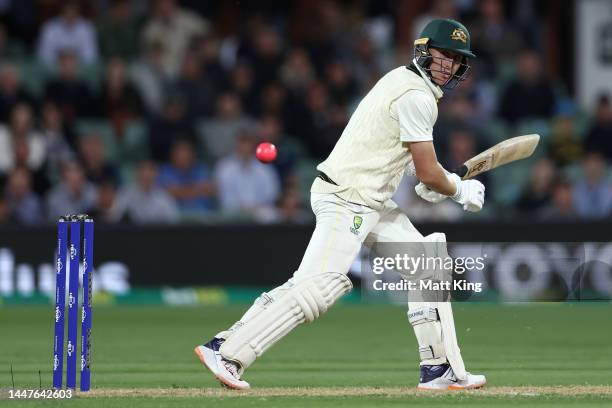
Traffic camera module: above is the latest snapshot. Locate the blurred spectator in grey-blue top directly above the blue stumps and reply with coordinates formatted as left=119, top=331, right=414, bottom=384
left=47, top=162, right=98, bottom=220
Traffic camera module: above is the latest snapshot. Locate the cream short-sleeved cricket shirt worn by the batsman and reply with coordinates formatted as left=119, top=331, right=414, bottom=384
left=310, top=66, right=442, bottom=209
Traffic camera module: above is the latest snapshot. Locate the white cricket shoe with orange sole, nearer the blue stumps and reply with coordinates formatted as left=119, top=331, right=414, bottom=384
left=195, top=337, right=251, bottom=390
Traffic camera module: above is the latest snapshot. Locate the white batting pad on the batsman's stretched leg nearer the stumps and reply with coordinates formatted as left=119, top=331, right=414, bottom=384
left=219, top=272, right=353, bottom=369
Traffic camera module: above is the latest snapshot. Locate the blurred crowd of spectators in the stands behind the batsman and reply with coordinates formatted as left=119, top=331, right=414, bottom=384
left=0, top=0, right=612, bottom=224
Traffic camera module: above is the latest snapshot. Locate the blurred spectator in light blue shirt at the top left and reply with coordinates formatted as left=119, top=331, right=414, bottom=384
left=38, top=0, right=98, bottom=67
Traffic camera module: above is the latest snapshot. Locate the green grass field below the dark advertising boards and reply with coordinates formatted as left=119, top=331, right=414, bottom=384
left=0, top=303, right=612, bottom=407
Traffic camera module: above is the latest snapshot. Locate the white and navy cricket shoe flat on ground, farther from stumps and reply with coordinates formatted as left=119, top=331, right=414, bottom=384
left=417, top=364, right=487, bottom=390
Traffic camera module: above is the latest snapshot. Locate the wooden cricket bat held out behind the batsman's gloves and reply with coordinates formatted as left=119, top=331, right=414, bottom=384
left=453, top=134, right=540, bottom=180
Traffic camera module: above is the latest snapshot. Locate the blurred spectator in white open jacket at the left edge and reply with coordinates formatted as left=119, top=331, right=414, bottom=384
left=0, top=103, right=46, bottom=174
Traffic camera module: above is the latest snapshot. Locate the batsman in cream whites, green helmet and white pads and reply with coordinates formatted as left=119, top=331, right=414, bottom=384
left=195, top=19, right=486, bottom=390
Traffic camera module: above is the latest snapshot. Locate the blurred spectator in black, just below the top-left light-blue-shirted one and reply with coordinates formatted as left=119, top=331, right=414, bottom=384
left=45, top=51, right=96, bottom=124
